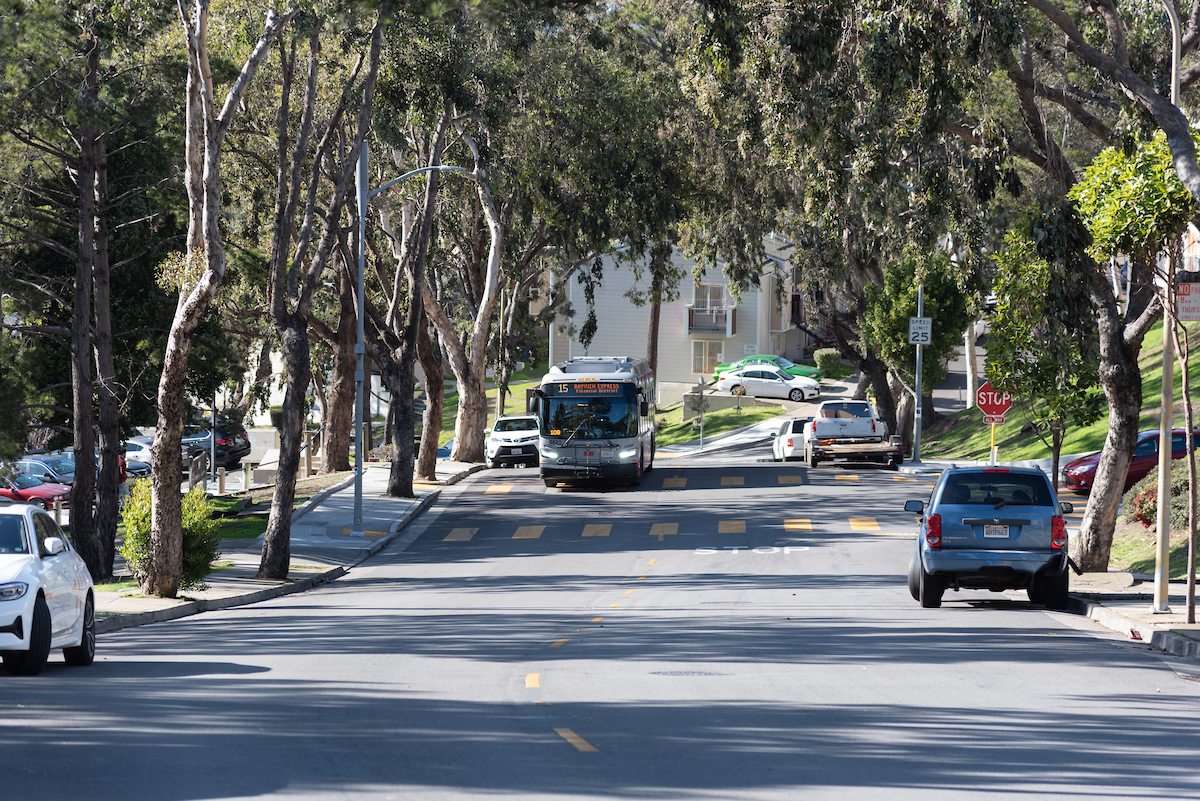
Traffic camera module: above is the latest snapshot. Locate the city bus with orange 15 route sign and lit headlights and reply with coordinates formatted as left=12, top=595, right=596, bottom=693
left=530, top=356, right=654, bottom=487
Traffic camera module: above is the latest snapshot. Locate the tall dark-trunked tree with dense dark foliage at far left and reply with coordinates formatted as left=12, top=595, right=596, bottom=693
left=0, top=2, right=182, bottom=579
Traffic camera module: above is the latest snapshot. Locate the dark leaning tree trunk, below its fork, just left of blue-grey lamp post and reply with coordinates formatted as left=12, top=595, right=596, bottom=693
left=254, top=314, right=312, bottom=579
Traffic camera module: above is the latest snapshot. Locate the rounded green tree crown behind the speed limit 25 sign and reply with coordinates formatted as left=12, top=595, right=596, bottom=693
left=863, top=252, right=971, bottom=387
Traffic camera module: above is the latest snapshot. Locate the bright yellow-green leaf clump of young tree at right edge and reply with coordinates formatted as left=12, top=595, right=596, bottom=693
left=1069, top=131, right=1198, bottom=261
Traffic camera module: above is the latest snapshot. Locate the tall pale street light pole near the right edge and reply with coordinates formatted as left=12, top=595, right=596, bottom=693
left=1150, top=0, right=1190, bottom=614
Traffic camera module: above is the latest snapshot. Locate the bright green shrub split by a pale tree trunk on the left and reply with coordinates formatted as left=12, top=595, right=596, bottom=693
left=121, top=480, right=221, bottom=590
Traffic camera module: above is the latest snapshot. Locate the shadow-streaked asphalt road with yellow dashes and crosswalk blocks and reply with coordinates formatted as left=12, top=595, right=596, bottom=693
left=7, top=446, right=1200, bottom=801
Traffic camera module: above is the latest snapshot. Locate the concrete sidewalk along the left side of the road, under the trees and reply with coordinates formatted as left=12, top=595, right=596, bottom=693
left=96, top=462, right=484, bottom=632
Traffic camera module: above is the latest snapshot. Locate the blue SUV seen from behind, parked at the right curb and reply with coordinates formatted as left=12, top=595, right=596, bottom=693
left=904, top=468, right=1072, bottom=609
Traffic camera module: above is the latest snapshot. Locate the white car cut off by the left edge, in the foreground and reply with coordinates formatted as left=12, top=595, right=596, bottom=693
left=0, top=501, right=96, bottom=676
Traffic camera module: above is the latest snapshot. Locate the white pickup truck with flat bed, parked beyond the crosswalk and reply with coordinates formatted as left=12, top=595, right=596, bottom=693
left=804, top=401, right=905, bottom=469
